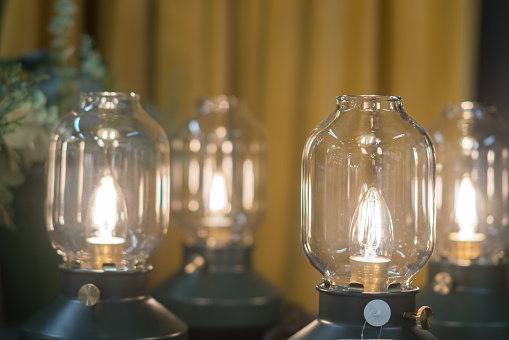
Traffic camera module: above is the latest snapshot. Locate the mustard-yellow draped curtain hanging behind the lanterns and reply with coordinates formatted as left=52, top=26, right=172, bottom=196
left=0, top=0, right=480, bottom=311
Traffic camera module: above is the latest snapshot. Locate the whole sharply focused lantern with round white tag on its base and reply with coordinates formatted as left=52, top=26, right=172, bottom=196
left=290, top=96, right=435, bottom=340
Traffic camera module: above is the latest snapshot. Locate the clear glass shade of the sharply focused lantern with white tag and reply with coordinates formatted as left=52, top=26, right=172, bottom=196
left=301, top=96, right=435, bottom=292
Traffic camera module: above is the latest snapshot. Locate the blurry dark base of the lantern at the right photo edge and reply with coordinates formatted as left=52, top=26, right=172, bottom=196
left=418, top=260, right=509, bottom=340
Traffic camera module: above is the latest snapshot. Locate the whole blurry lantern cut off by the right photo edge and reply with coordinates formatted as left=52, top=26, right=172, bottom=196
left=420, top=102, right=509, bottom=339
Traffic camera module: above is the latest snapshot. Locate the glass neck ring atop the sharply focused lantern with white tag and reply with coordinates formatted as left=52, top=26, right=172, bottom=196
left=337, top=96, right=403, bottom=112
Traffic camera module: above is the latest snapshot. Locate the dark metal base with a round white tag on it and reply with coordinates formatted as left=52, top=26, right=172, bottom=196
left=288, top=284, right=437, bottom=340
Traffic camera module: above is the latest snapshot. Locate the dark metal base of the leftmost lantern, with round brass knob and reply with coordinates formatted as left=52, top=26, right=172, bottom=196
left=18, top=268, right=187, bottom=340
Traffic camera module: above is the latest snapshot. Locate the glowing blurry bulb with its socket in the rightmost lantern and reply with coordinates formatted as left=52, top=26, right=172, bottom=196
left=449, top=176, right=486, bottom=265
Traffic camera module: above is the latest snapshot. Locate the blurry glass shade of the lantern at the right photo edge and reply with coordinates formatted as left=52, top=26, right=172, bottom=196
left=429, top=102, right=509, bottom=265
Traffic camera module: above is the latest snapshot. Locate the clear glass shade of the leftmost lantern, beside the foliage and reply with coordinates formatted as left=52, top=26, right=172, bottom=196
left=46, top=92, right=170, bottom=271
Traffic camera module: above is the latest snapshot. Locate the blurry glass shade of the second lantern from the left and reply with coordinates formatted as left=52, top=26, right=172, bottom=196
left=170, top=95, right=267, bottom=248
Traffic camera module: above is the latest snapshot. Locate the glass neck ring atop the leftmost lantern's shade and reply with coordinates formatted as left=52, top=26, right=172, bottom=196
left=80, top=92, right=140, bottom=114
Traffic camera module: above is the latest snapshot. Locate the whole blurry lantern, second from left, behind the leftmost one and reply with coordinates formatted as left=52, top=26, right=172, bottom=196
left=154, top=95, right=282, bottom=339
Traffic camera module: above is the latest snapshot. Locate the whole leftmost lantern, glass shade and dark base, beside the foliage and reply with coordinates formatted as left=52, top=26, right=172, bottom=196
left=19, top=92, right=187, bottom=340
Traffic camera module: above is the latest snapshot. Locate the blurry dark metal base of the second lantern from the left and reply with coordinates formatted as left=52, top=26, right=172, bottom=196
left=153, top=245, right=282, bottom=340
